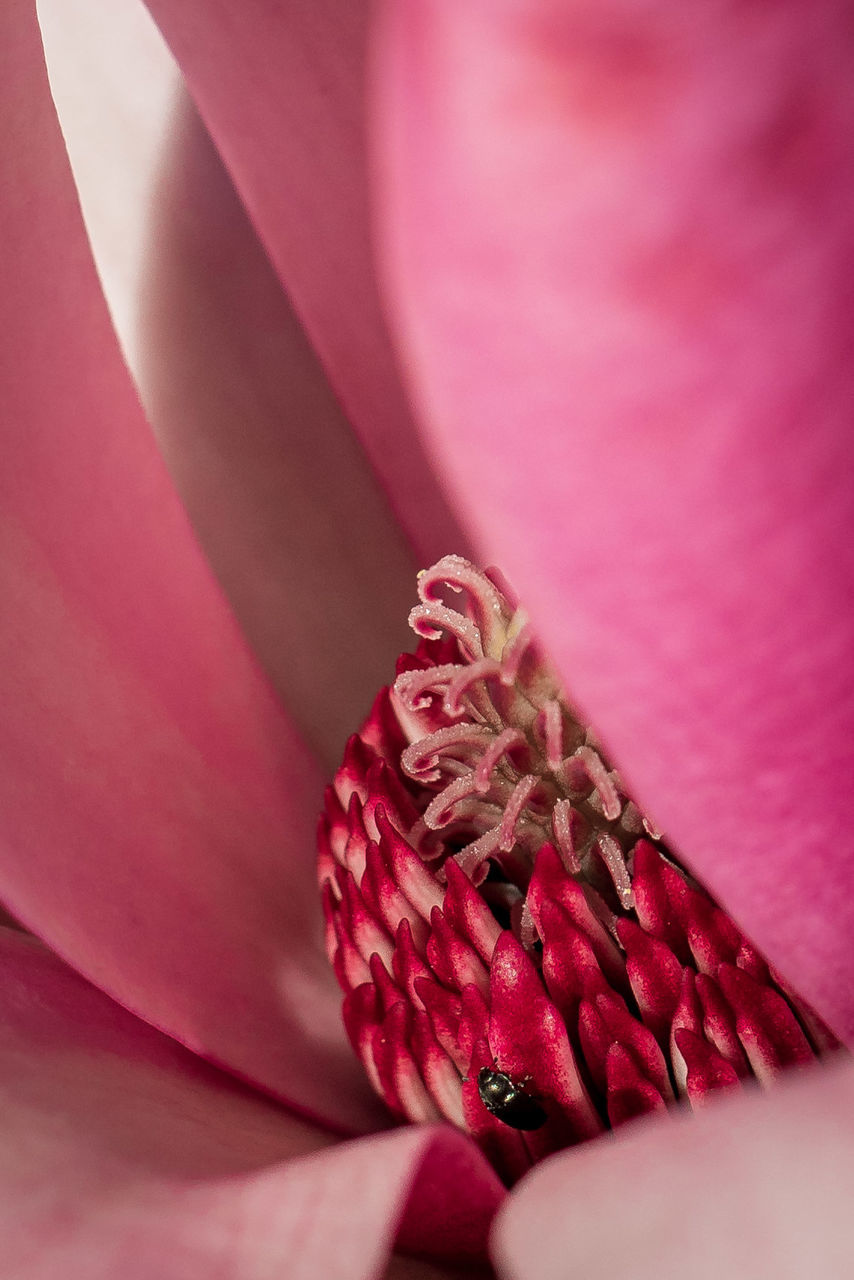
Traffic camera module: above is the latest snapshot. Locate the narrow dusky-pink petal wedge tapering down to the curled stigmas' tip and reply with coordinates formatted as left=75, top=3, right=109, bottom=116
left=149, top=0, right=461, bottom=561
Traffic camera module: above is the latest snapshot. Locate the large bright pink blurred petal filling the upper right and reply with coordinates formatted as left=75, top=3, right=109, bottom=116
left=376, top=0, right=854, bottom=1037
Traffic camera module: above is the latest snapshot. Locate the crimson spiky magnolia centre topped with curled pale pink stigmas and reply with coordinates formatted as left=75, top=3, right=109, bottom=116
left=319, top=556, right=836, bottom=1180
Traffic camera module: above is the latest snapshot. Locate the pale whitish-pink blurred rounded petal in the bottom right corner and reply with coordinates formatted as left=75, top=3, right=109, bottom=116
left=494, top=1062, right=854, bottom=1280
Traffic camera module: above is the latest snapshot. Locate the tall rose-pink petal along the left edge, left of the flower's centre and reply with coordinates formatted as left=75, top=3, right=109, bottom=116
left=0, top=4, right=376, bottom=1124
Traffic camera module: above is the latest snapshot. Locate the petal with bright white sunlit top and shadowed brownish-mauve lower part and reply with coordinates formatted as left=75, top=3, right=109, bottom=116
left=42, top=0, right=417, bottom=769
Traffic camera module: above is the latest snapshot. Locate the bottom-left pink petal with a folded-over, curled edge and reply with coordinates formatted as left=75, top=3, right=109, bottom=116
left=0, top=931, right=499, bottom=1280
